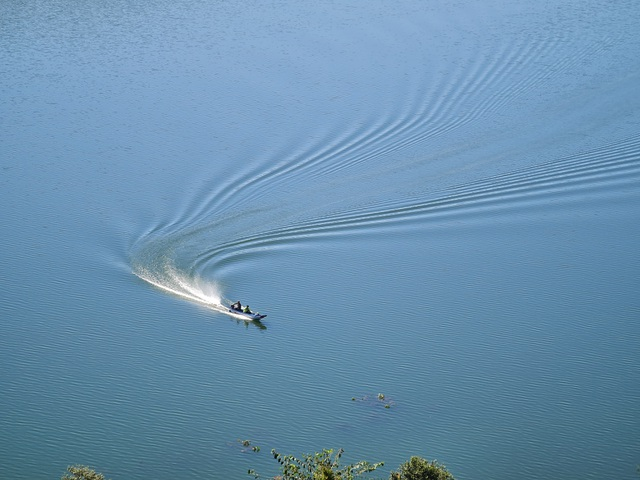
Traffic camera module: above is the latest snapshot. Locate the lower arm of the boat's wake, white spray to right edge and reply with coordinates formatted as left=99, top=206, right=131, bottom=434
left=133, top=134, right=640, bottom=312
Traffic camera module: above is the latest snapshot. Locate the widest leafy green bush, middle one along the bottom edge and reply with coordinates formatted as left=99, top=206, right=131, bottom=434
left=249, top=449, right=384, bottom=480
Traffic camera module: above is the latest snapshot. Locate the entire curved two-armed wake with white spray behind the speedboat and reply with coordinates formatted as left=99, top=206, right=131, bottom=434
left=132, top=6, right=640, bottom=316
